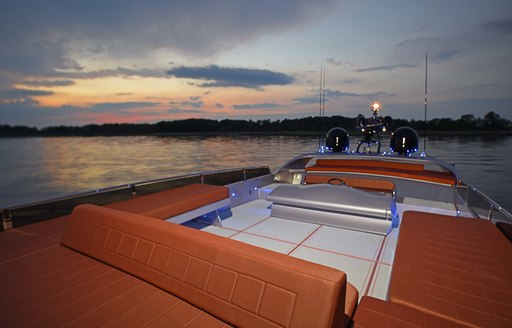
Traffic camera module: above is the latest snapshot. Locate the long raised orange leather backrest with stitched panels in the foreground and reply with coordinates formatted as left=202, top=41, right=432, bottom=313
left=61, top=205, right=346, bottom=327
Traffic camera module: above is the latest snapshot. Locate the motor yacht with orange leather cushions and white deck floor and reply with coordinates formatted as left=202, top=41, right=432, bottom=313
left=0, top=104, right=512, bottom=327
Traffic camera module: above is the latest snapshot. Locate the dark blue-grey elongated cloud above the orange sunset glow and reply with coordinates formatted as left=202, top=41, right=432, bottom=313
left=167, top=65, right=294, bottom=89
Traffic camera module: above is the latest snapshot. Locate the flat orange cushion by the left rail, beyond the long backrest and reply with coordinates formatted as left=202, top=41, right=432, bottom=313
left=106, top=183, right=229, bottom=220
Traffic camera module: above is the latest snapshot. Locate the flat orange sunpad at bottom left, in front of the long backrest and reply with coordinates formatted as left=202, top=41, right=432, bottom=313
left=0, top=217, right=228, bottom=328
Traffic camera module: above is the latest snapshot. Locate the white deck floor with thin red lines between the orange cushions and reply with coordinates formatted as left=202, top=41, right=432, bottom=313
left=196, top=183, right=460, bottom=300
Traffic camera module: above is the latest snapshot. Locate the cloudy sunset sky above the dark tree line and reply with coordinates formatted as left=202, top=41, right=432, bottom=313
left=0, top=0, right=512, bottom=128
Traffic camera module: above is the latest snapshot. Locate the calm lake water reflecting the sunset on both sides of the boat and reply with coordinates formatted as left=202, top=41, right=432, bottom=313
left=0, top=136, right=512, bottom=211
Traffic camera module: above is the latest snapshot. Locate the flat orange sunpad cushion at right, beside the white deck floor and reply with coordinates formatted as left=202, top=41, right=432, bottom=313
left=389, top=212, right=512, bottom=327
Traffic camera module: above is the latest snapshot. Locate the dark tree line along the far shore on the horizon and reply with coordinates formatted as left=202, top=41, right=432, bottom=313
left=0, top=111, right=512, bottom=137
